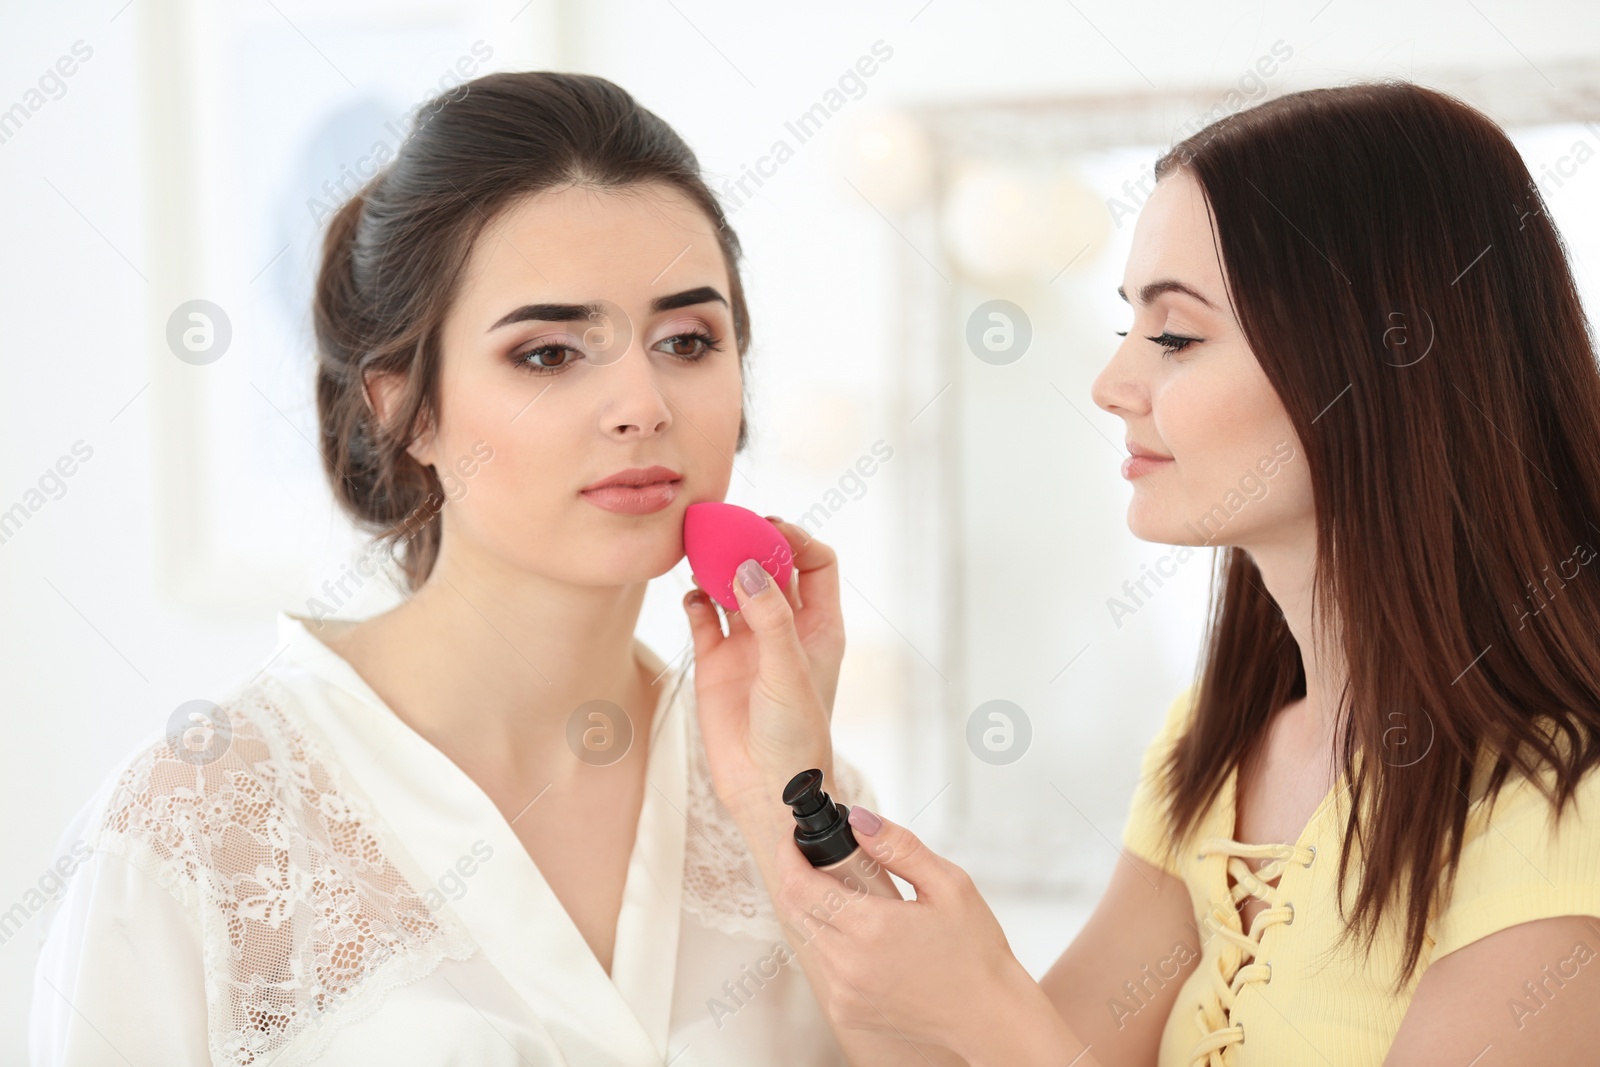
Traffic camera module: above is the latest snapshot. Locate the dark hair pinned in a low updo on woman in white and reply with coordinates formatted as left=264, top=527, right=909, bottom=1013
left=312, top=72, right=750, bottom=590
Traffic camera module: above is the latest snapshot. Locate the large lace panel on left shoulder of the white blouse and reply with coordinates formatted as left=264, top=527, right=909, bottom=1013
left=90, top=680, right=477, bottom=1067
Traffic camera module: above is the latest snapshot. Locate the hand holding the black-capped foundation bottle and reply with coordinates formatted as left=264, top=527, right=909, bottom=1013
left=773, top=806, right=1098, bottom=1067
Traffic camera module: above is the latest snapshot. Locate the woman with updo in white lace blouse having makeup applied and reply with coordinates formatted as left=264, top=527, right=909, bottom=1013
left=32, top=74, right=952, bottom=1067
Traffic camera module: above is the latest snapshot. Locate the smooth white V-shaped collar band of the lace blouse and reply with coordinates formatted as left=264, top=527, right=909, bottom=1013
left=264, top=613, right=691, bottom=1067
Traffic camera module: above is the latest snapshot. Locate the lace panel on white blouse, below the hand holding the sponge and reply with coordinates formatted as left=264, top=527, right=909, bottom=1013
left=683, top=678, right=875, bottom=941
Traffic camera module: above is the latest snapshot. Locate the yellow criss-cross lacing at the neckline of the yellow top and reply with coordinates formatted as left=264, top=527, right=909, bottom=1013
left=1190, top=837, right=1317, bottom=1067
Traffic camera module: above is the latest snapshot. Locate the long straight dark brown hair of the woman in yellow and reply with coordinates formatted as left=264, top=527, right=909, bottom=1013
left=1155, top=82, right=1600, bottom=992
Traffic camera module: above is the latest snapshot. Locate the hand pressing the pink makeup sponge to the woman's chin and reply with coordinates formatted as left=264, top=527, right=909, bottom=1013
left=683, top=522, right=845, bottom=822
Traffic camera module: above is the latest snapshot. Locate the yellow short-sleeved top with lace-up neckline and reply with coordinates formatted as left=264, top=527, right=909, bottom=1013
left=1110, top=686, right=1600, bottom=1067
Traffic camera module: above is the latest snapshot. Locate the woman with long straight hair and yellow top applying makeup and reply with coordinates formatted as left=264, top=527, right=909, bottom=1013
left=758, top=83, right=1600, bottom=1067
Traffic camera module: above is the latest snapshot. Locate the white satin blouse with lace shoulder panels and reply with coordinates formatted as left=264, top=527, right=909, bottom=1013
left=29, top=614, right=872, bottom=1067
